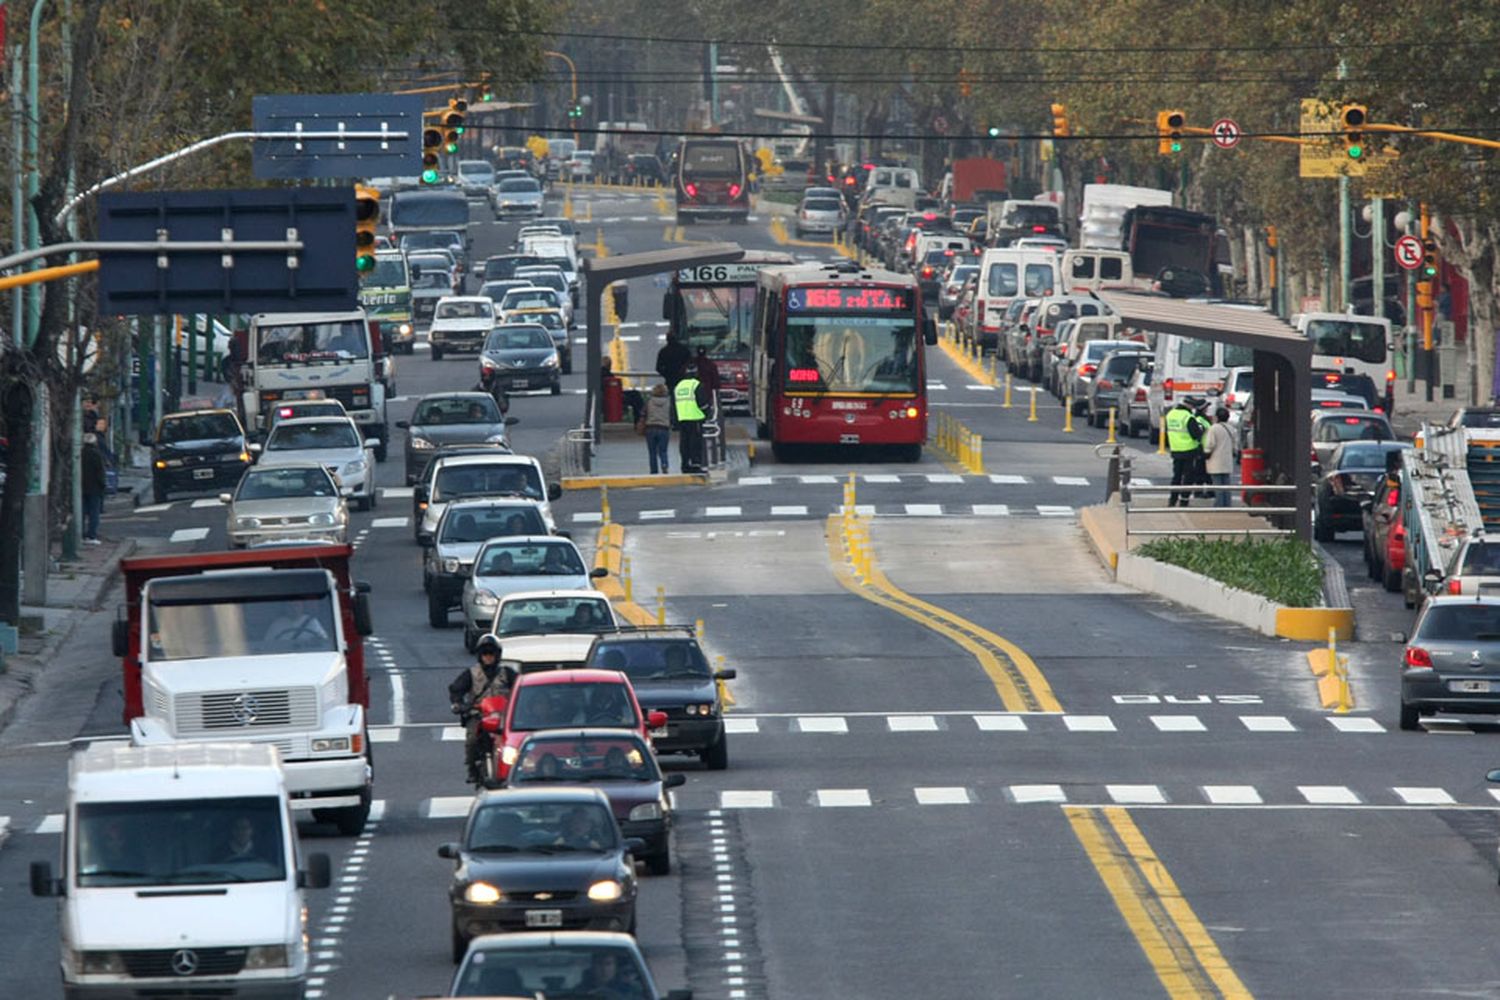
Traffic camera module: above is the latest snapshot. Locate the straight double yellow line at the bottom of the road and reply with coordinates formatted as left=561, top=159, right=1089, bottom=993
left=1064, top=805, right=1251, bottom=1000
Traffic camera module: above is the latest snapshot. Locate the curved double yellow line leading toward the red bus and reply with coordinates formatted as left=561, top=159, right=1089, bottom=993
left=824, top=517, right=1062, bottom=712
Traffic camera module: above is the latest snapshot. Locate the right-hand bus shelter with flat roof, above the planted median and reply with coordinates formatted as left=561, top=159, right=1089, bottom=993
left=1098, top=291, right=1313, bottom=540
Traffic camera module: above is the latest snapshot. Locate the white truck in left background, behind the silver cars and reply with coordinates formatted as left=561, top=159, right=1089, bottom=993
left=242, top=309, right=390, bottom=462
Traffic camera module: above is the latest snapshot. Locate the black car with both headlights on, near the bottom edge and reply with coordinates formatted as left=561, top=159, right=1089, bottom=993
left=438, top=786, right=642, bottom=961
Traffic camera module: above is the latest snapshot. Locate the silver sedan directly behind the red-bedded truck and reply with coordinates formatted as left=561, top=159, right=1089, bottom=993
left=219, top=462, right=350, bottom=549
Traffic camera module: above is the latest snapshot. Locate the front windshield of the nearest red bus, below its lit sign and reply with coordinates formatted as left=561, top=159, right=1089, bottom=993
left=783, top=313, right=920, bottom=393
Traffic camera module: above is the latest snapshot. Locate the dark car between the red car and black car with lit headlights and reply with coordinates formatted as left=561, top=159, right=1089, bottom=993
left=506, top=728, right=687, bottom=876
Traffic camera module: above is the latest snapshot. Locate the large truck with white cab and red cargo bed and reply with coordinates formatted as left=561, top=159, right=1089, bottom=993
left=114, top=544, right=374, bottom=835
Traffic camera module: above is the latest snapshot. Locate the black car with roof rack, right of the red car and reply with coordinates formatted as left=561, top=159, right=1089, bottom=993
left=584, top=625, right=735, bottom=771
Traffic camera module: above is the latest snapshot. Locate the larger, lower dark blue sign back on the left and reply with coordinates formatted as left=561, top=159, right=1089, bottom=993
left=99, top=187, right=359, bottom=316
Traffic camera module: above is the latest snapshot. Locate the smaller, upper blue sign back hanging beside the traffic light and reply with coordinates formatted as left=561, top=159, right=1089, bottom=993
left=251, top=94, right=423, bottom=180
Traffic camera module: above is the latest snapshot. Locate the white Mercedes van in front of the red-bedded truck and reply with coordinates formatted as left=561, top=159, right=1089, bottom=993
left=32, top=744, right=330, bottom=999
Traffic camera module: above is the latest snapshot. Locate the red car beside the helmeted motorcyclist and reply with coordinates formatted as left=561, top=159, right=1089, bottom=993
left=495, top=670, right=666, bottom=780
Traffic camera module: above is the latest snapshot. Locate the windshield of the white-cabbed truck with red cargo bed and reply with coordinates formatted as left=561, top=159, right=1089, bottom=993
left=146, top=594, right=338, bottom=659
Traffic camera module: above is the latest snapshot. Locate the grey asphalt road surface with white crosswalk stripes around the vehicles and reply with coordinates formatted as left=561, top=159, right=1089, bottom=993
left=0, top=192, right=1500, bottom=1000
